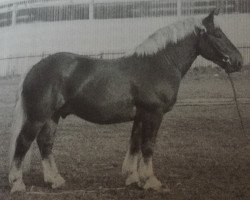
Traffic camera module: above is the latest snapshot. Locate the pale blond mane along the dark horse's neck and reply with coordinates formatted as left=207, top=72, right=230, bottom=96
left=132, top=17, right=204, bottom=55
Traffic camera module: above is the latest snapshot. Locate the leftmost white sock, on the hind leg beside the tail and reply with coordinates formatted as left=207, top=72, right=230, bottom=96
left=9, top=162, right=26, bottom=193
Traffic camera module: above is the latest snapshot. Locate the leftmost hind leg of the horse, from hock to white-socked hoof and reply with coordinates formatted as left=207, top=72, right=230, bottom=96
left=9, top=120, right=43, bottom=192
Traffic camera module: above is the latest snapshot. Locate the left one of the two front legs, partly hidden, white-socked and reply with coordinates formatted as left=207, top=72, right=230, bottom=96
left=122, top=112, right=141, bottom=186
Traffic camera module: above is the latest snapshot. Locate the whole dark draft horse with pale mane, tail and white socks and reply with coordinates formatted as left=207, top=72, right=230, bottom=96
left=9, top=9, right=243, bottom=192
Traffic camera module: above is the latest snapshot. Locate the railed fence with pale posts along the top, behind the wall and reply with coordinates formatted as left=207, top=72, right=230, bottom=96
left=0, top=0, right=250, bottom=27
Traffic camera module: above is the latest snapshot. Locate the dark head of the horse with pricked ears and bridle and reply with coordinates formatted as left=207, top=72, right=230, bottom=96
left=197, top=9, right=243, bottom=73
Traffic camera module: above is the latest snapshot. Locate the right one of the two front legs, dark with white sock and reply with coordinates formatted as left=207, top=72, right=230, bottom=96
left=138, top=109, right=166, bottom=191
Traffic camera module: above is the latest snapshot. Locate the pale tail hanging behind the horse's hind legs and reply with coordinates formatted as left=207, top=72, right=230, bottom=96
left=9, top=76, right=31, bottom=171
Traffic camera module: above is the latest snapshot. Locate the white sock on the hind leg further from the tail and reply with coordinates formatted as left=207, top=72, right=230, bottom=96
left=42, top=155, right=65, bottom=188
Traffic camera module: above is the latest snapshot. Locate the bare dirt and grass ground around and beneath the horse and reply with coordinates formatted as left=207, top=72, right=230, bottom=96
left=0, top=68, right=250, bottom=200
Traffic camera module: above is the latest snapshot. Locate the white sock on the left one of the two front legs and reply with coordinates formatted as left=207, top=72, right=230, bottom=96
left=122, top=150, right=139, bottom=185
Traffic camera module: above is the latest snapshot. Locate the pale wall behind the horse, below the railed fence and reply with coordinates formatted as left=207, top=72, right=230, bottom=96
left=0, top=14, right=250, bottom=75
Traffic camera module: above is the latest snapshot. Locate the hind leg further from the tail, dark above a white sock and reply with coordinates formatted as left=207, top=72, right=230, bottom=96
left=37, top=116, right=65, bottom=188
